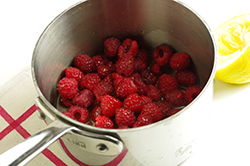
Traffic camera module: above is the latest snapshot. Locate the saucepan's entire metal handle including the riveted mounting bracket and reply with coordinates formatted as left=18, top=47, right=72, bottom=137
left=0, top=97, right=124, bottom=166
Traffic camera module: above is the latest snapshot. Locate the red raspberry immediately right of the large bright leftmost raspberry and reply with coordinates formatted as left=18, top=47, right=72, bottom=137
left=80, top=73, right=101, bottom=90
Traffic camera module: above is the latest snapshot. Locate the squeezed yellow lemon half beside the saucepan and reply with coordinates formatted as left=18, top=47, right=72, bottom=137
left=214, top=14, right=250, bottom=84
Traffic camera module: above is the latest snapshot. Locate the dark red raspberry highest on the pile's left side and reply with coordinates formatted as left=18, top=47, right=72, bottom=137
left=73, top=54, right=94, bottom=74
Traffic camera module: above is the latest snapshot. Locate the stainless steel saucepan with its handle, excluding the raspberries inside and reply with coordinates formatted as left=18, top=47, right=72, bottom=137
left=0, top=0, right=217, bottom=166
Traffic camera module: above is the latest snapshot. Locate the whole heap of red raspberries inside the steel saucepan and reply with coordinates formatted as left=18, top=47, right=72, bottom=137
left=57, top=37, right=201, bottom=129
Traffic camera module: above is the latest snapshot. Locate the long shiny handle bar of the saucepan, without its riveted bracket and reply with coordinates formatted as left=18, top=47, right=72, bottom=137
left=0, top=120, right=75, bottom=166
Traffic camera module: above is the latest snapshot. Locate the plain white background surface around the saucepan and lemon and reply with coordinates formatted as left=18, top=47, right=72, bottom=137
left=0, top=0, right=250, bottom=166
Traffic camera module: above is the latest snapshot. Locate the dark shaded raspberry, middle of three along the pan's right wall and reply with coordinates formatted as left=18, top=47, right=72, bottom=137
left=175, top=70, right=197, bottom=86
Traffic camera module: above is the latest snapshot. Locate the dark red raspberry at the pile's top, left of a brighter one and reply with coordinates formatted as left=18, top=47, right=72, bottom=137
left=104, top=37, right=121, bottom=57
